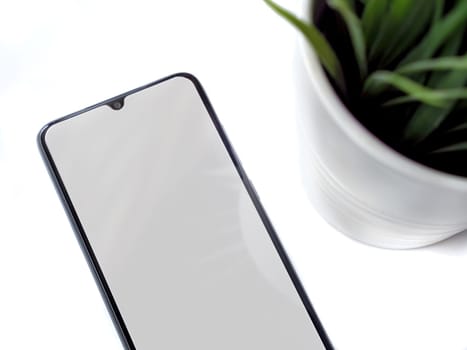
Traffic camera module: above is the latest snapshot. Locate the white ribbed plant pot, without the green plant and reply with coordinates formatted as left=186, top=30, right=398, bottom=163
left=297, top=0, right=467, bottom=249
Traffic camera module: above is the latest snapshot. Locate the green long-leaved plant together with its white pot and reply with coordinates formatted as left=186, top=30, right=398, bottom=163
left=265, top=0, right=467, bottom=248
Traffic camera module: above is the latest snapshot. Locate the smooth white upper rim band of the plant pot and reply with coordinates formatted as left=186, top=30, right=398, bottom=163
left=300, top=0, right=467, bottom=192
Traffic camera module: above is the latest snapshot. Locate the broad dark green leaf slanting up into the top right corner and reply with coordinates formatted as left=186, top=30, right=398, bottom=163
left=399, top=0, right=467, bottom=66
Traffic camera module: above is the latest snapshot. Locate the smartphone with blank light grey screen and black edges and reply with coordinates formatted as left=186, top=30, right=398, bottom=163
left=38, top=73, right=332, bottom=350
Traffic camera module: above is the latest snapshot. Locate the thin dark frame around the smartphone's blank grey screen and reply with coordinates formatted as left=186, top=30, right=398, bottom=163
left=37, top=72, right=334, bottom=350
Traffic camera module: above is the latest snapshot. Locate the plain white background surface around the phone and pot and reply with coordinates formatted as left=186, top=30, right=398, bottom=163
left=0, top=0, right=467, bottom=350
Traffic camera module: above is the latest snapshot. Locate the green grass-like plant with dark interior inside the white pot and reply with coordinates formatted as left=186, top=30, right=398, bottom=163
left=264, top=0, right=467, bottom=176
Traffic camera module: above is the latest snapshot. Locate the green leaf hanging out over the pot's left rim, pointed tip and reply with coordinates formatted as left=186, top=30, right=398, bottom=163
left=264, top=0, right=345, bottom=92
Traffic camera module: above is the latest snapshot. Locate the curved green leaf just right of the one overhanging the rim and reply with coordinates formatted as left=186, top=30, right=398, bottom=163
left=328, top=0, right=368, bottom=81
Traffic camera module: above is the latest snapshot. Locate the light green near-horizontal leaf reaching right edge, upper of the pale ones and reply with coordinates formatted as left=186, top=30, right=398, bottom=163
left=396, top=55, right=467, bottom=74
